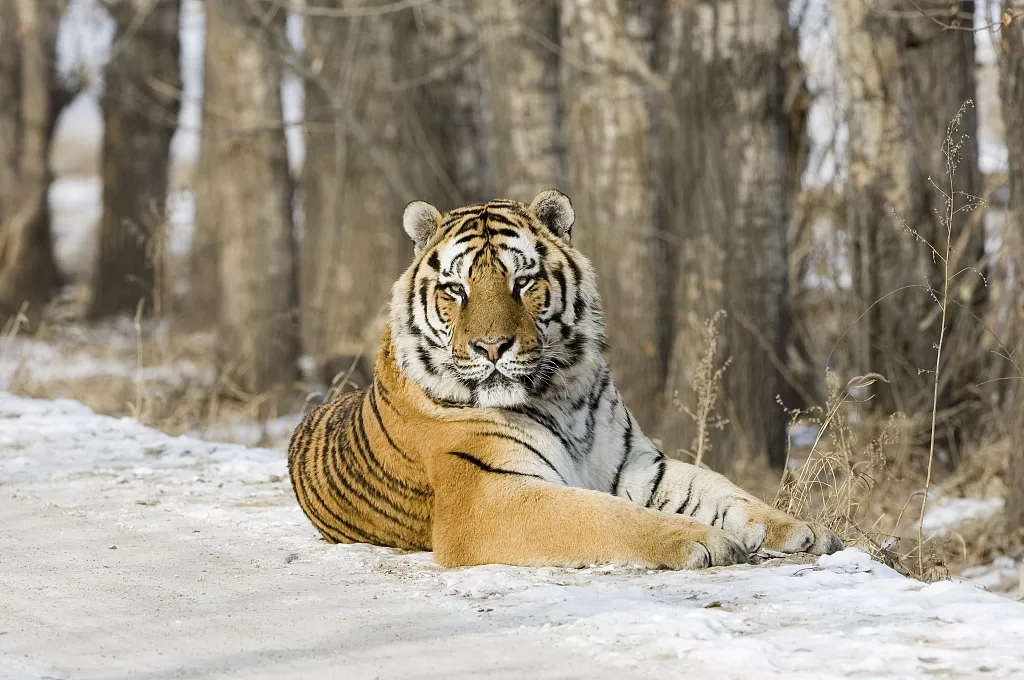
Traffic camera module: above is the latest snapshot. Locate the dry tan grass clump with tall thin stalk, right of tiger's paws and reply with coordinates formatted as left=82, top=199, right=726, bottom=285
left=775, top=101, right=1022, bottom=581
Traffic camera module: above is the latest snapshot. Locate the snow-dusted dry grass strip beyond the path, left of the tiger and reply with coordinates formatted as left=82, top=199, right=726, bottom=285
left=0, top=288, right=307, bottom=445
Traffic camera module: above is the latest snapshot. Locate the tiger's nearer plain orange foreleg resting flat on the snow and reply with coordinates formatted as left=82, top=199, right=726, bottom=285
left=432, top=454, right=749, bottom=568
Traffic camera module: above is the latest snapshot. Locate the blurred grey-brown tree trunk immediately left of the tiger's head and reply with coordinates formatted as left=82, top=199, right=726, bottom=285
left=300, top=0, right=417, bottom=381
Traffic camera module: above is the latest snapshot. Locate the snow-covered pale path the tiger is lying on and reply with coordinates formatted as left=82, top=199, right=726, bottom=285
left=0, top=393, right=1024, bottom=680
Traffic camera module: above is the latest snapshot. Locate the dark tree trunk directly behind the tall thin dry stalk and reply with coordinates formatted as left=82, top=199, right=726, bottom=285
left=901, top=0, right=997, bottom=456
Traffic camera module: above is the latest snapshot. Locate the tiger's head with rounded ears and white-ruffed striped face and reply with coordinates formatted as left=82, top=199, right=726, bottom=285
left=390, top=190, right=604, bottom=408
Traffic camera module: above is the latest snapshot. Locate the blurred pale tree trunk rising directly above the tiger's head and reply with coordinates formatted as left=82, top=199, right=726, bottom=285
left=476, top=0, right=565, bottom=197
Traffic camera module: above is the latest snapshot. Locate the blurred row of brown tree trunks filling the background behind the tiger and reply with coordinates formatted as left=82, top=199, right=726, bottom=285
left=6, top=0, right=1024, bottom=507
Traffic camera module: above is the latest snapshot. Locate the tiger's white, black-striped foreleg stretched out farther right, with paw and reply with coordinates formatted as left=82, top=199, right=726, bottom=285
left=612, top=442, right=843, bottom=555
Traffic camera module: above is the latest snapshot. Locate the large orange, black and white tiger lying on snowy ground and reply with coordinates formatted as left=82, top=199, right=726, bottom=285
left=288, top=189, right=843, bottom=569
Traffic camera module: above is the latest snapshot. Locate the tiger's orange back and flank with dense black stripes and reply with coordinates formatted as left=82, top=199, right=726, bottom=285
left=288, top=372, right=433, bottom=550
